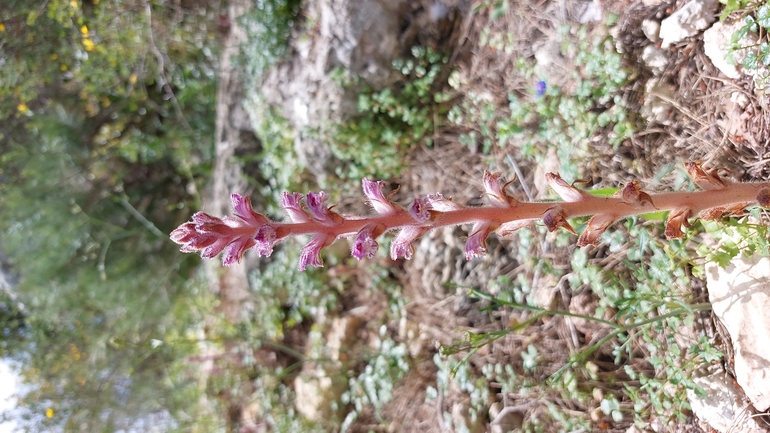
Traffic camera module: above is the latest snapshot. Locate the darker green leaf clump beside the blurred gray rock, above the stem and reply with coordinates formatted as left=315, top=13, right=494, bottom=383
left=328, top=47, right=450, bottom=180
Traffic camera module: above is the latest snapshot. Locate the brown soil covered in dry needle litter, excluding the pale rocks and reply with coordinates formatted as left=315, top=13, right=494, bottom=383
left=206, top=0, right=770, bottom=432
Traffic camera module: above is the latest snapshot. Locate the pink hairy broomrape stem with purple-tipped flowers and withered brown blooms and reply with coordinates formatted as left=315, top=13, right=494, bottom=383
left=171, top=162, right=770, bottom=271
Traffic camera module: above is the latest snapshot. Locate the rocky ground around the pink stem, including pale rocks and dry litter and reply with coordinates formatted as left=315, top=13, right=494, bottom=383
left=209, top=0, right=770, bottom=432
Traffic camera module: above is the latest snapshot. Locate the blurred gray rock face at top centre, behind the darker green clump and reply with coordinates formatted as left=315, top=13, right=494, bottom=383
left=258, top=0, right=462, bottom=179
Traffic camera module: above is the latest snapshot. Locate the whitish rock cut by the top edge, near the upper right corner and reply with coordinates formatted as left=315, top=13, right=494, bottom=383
left=660, top=0, right=719, bottom=50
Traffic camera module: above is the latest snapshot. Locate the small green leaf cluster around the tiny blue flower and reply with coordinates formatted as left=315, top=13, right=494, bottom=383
left=448, top=21, right=635, bottom=177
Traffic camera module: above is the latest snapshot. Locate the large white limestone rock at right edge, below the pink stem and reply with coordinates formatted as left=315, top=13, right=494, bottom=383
left=706, top=255, right=770, bottom=411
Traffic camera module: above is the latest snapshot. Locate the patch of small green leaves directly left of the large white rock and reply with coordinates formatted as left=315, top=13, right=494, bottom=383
left=442, top=218, right=720, bottom=431
